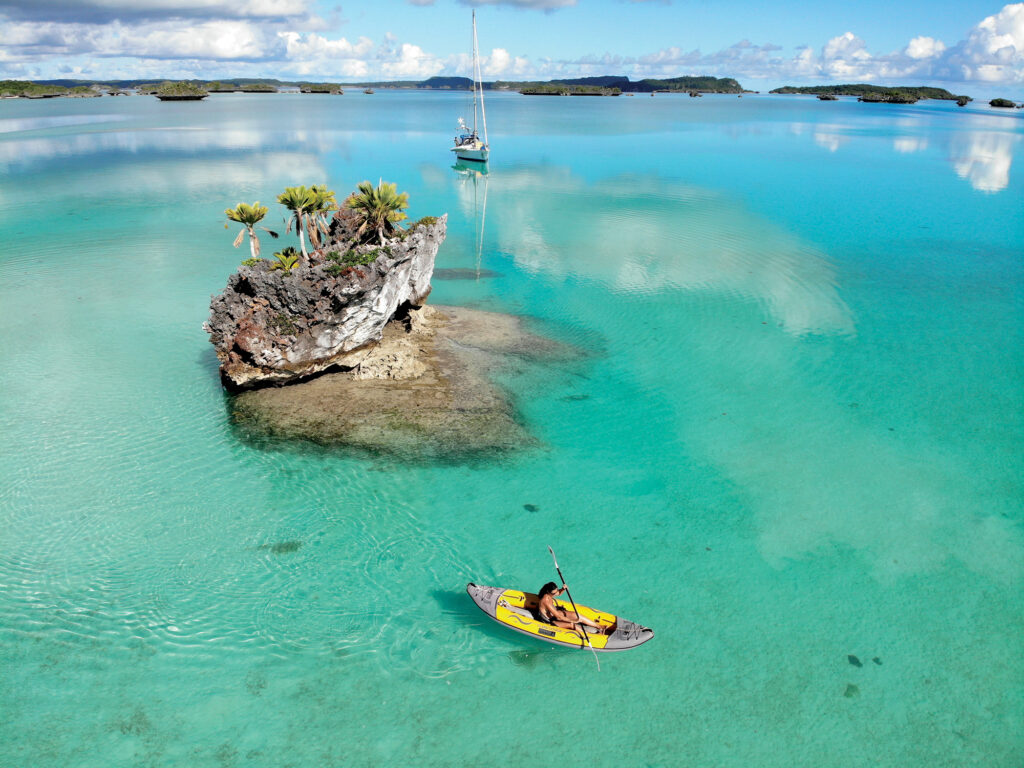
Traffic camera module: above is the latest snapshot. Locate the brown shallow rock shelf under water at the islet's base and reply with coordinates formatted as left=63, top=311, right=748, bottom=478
left=231, top=306, right=574, bottom=458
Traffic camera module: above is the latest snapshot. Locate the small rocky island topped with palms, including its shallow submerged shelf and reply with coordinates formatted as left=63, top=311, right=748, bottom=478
left=205, top=182, right=571, bottom=457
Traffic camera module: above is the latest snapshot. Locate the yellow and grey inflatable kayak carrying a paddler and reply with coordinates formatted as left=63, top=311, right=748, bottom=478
left=466, top=582, right=654, bottom=651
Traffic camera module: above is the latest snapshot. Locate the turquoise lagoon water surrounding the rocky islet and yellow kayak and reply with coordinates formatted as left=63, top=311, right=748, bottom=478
left=0, top=91, right=1024, bottom=768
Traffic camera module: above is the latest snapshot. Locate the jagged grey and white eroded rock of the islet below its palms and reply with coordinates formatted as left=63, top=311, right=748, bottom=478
left=204, top=212, right=447, bottom=390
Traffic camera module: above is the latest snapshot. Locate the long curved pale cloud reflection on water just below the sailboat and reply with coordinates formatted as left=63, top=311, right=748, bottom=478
left=460, top=167, right=854, bottom=336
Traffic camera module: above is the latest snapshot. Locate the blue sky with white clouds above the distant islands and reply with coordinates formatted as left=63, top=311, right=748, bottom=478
left=0, top=0, right=1024, bottom=97
